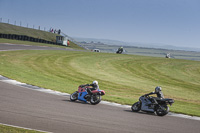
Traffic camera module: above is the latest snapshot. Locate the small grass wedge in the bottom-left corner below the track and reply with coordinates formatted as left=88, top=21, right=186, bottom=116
left=0, top=124, right=41, bottom=133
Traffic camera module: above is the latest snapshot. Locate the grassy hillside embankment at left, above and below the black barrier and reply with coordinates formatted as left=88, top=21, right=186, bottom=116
left=0, top=23, right=83, bottom=50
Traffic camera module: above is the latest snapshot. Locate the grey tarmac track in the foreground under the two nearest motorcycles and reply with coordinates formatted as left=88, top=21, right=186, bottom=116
left=0, top=45, right=200, bottom=133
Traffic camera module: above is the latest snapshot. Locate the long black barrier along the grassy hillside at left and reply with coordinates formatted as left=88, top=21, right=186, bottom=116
left=0, top=33, right=60, bottom=45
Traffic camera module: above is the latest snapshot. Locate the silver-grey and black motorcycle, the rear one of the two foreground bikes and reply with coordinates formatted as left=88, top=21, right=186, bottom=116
left=131, top=95, right=174, bottom=116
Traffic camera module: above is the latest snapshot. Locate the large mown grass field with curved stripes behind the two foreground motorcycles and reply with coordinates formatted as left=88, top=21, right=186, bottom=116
left=0, top=50, right=200, bottom=116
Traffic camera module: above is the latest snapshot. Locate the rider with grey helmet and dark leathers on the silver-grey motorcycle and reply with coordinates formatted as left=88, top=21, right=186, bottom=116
left=145, top=86, right=164, bottom=103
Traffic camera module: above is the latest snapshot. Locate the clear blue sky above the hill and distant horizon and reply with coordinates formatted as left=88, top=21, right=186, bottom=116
left=0, top=0, right=200, bottom=48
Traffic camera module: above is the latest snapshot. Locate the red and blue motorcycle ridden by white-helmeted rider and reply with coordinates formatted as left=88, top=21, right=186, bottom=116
left=70, top=85, right=105, bottom=105
